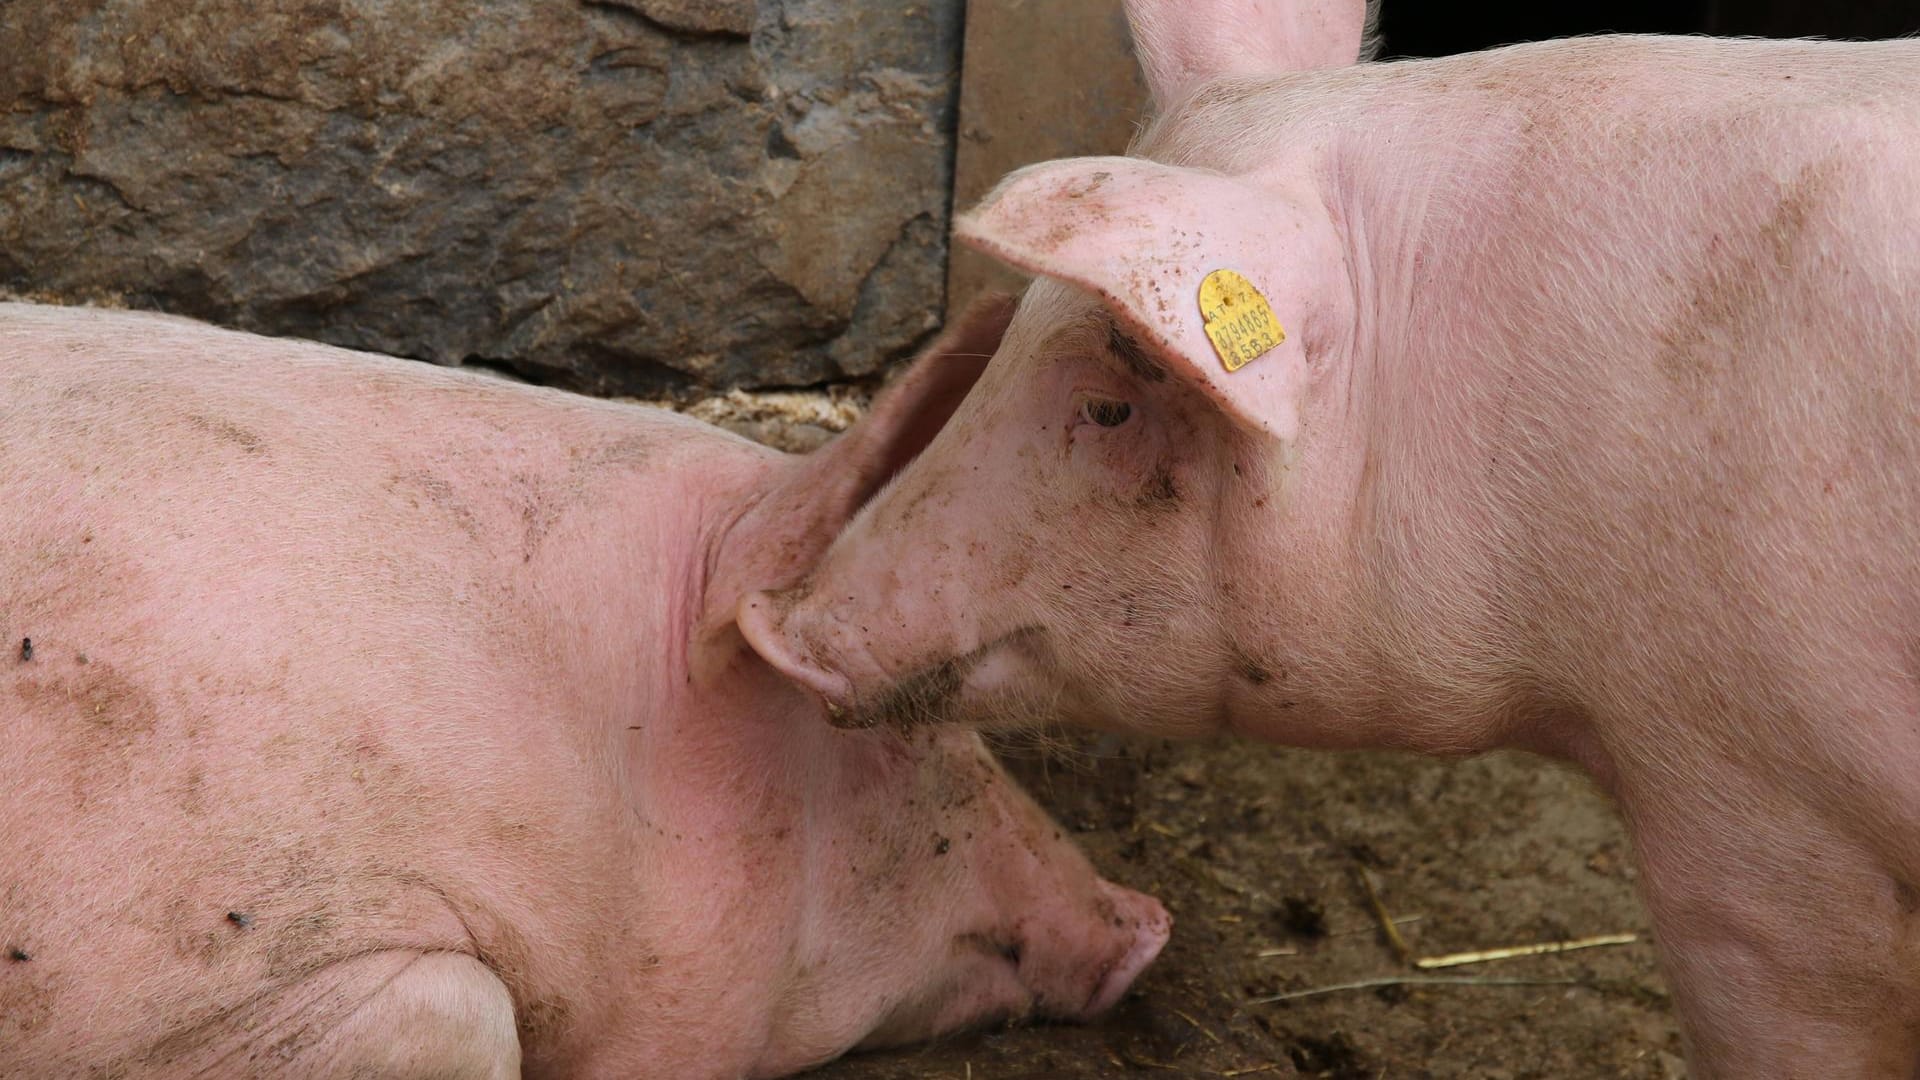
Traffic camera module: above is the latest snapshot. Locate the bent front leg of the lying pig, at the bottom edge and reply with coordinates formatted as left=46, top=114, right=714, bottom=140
left=134, top=951, right=520, bottom=1080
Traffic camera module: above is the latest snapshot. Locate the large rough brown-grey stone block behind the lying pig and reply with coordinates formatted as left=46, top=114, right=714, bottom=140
left=0, top=0, right=962, bottom=394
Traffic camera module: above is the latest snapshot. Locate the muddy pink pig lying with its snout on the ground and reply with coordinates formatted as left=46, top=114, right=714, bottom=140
left=0, top=304, right=1167, bottom=1078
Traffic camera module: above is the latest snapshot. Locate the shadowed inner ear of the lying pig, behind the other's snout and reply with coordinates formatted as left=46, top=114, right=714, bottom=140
left=789, top=292, right=1016, bottom=550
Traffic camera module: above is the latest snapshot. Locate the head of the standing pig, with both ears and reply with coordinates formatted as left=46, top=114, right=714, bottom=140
left=741, top=4, right=1392, bottom=744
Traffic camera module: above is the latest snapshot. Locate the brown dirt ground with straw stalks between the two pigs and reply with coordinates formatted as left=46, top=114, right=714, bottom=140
left=816, top=736, right=1686, bottom=1080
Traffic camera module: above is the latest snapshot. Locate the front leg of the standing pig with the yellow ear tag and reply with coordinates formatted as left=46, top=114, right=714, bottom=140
left=1620, top=761, right=1920, bottom=1080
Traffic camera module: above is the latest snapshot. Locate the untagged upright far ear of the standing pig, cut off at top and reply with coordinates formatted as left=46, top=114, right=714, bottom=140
left=1127, top=0, right=1373, bottom=108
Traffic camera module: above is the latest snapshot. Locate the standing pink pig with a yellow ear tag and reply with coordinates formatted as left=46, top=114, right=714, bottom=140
left=743, top=0, right=1920, bottom=1078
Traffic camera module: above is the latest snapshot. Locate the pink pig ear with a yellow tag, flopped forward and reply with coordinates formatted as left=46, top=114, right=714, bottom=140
left=954, top=158, right=1354, bottom=438
